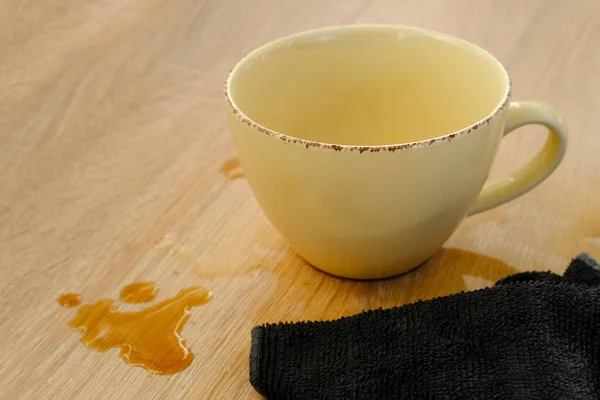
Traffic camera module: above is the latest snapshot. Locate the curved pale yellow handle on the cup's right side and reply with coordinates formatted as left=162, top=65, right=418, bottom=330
left=469, top=101, right=567, bottom=215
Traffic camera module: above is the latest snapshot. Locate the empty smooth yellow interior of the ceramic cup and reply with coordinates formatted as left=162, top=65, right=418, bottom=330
left=227, top=26, right=510, bottom=146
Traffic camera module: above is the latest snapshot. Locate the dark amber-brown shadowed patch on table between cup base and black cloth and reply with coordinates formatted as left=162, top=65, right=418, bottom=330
left=253, top=248, right=520, bottom=324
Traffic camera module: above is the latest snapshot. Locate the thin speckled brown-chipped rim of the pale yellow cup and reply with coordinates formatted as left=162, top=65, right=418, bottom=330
left=224, top=24, right=512, bottom=153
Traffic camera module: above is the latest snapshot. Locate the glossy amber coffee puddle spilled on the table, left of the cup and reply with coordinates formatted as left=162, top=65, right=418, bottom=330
left=59, top=282, right=212, bottom=375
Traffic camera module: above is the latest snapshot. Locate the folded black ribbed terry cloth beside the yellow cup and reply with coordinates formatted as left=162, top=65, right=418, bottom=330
left=250, top=254, right=600, bottom=400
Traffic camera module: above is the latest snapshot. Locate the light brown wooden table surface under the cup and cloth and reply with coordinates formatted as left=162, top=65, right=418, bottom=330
left=0, top=0, right=600, bottom=399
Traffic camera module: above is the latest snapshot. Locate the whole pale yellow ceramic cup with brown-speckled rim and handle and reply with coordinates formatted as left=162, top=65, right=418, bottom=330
left=226, top=25, right=567, bottom=279
